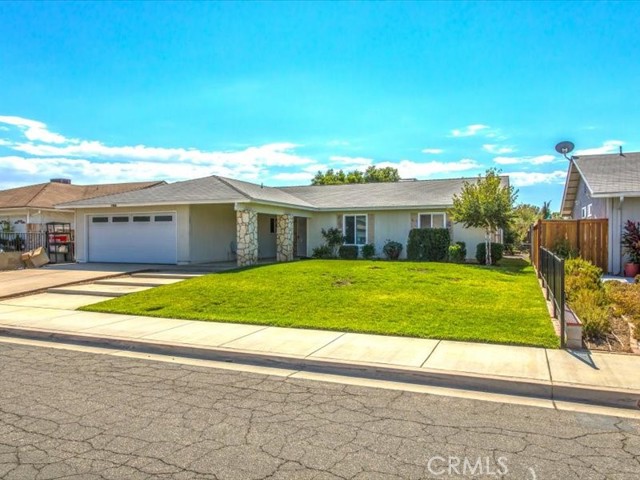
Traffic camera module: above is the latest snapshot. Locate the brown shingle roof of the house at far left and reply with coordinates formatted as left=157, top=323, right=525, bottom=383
left=0, top=181, right=165, bottom=208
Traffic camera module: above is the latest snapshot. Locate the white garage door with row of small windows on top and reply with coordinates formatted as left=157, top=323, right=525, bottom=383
left=89, top=212, right=177, bottom=263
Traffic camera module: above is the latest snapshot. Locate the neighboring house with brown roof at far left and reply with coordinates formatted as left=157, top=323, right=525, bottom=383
left=0, top=179, right=165, bottom=233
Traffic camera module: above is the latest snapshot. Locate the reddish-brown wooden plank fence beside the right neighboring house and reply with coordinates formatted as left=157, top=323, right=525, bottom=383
left=531, top=218, right=609, bottom=272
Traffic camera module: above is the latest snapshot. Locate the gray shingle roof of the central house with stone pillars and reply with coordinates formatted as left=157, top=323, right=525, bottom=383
left=58, top=175, right=508, bottom=209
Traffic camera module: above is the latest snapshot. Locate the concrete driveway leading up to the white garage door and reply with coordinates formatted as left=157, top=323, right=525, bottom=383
left=0, top=263, right=159, bottom=299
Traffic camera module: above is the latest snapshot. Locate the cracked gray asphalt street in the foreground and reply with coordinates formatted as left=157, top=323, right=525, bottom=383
left=0, top=342, right=640, bottom=480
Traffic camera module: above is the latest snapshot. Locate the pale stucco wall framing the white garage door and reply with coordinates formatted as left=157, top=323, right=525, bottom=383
left=76, top=205, right=191, bottom=264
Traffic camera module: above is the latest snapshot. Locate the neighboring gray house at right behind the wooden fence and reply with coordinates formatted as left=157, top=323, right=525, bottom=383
left=560, top=151, right=640, bottom=273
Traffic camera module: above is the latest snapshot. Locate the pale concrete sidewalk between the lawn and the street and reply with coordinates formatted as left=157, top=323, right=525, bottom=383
left=0, top=297, right=640, bottom=409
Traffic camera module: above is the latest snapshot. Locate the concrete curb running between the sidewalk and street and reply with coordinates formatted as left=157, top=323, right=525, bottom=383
left=0, top=325, right=640, bottom=410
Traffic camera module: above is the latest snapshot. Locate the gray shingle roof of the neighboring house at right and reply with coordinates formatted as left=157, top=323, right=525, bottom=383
left=573, top=152, right=640, bottom=195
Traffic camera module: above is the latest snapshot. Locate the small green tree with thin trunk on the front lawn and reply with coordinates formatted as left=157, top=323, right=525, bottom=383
left=449, top=168, right=517, bottom=265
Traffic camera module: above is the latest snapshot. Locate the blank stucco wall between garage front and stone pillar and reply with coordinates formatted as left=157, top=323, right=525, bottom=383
left=189, top=204, right=236, bottom=263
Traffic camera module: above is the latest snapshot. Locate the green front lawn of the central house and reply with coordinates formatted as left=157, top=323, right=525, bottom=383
left=82, top=259, right=558, bottom=347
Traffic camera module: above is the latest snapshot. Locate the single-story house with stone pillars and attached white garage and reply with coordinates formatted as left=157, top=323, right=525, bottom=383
left=59, top=176, right=508, bottom=265
